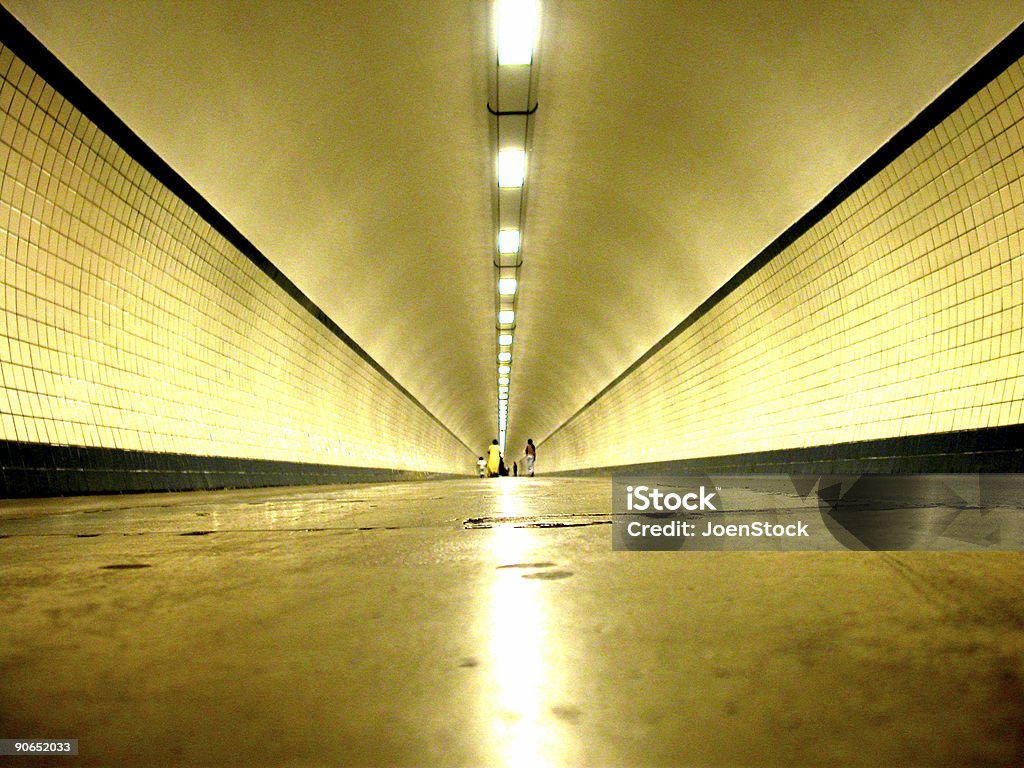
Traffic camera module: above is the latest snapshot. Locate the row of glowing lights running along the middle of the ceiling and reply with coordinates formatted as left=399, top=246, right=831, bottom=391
left=487, top=0, right=539, bottom=453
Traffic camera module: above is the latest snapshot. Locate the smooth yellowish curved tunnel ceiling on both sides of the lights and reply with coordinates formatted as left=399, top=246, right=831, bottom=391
left=3, top=0, right=1024, bottom=456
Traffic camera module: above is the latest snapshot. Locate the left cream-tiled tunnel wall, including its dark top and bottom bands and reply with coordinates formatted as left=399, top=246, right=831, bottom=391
left=0, top=27, right=475, bottom=497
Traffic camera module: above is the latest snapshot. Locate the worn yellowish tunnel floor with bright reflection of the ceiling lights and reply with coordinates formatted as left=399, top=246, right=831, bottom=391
left=0, top=477, right=1024, bottom=768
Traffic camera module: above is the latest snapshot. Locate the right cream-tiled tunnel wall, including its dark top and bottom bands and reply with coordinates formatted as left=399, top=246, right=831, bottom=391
left=539, top=30, right=1024, bottom=473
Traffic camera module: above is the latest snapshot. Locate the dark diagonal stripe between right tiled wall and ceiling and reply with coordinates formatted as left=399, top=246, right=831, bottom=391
left=538, top=24, right=1024, bottom=447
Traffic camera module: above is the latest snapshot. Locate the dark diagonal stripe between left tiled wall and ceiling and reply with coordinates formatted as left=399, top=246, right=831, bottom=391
left=0, top=5, right=476, bottom=456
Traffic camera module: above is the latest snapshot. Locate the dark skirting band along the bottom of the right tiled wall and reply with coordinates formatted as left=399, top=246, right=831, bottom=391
left=539, top=424, right=1024, bottom=476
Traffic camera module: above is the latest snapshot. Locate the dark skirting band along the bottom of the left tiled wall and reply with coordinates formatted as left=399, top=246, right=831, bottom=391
left=0, top=440, right=455, bottom=499
